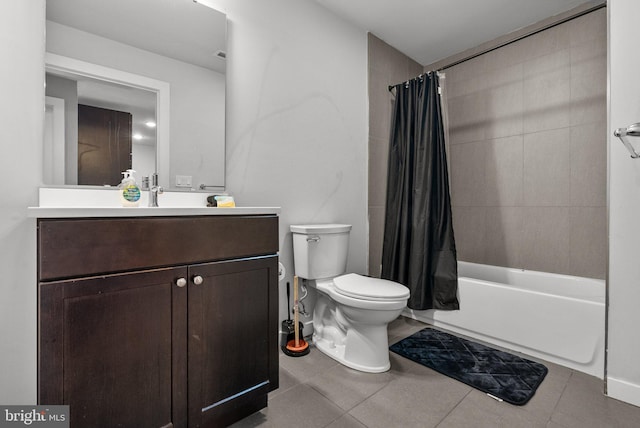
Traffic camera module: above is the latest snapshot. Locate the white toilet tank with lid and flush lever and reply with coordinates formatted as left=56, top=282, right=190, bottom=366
left=290, top=224, right=351, bottom=279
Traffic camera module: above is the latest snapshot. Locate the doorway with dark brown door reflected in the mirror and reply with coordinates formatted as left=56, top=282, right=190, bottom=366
left=44, top=64, right=157, bottom=186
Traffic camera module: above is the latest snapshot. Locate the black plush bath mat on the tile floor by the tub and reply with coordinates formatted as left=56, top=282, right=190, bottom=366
left=389, top=328, right=547, bottom=406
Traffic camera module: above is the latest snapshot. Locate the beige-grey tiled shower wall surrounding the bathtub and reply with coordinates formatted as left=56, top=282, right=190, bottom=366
left=369, top=9, right=607, bottom=278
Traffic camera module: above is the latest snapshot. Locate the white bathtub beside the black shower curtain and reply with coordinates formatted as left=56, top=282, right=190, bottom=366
left=403, top=262, right=605, bottom=379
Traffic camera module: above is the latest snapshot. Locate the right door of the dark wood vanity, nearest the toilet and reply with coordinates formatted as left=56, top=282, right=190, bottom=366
left=188, top=256, right=278, bottom=427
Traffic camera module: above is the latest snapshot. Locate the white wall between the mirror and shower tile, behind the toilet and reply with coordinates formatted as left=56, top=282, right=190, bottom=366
left=201, top=0, right=368, bottom=326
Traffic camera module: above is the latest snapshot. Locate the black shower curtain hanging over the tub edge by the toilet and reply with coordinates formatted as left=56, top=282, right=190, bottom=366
left=382, top=72, right=459, bottom=310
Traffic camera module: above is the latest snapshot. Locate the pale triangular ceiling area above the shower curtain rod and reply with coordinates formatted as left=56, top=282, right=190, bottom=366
left=315, top=0, right=594, bottom=65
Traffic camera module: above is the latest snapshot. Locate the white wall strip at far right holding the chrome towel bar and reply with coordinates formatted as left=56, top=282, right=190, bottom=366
left=607, top=0, right=640, bottom=406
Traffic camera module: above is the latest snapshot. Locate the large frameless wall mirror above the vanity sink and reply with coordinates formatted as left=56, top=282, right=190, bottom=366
left=44, top=0, right=226, bottom=192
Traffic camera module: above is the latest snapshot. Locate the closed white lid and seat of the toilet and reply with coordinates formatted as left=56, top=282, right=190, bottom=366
left=333, top=273, right=409, bottom=301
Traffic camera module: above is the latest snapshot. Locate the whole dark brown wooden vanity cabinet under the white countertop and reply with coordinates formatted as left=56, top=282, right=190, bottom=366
left=38, top=215, right=278, bottom=427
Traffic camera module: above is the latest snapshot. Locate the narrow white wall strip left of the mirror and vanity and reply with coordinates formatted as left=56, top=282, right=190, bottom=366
left=0, top=0, right=45, bottom=404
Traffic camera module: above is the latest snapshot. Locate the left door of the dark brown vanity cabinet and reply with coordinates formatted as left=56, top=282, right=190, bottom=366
left=38, top=267, right=188, bottom=428
